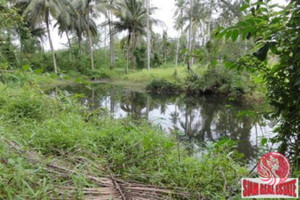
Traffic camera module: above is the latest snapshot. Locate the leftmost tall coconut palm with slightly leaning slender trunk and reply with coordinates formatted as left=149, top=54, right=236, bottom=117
left=23, top=0, right=66, bottom=73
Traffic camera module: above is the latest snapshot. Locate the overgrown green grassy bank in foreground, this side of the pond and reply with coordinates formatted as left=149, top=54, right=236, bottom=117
left=0, top=72, right=246, bottom=199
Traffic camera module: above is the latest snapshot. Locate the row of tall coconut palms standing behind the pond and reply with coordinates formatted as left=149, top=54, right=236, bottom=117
left=1, top=0, right=243, bottom=73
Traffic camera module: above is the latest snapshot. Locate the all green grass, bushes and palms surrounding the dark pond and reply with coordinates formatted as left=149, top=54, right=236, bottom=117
left=0, top=0, right=300, bottom=199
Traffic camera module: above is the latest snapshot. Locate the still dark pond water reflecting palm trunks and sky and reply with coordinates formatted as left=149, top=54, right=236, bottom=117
left=52, top=84, right=273, bottom=161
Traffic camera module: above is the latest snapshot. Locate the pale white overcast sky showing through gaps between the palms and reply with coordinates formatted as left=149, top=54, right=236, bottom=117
left=45, top=0, right=286, bottom=49
